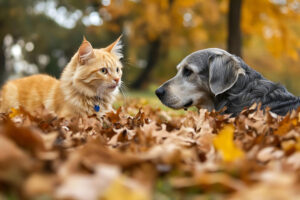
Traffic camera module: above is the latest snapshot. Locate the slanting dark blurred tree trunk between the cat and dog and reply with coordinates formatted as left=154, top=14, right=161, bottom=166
left=131, top=38, right=161, bottom=89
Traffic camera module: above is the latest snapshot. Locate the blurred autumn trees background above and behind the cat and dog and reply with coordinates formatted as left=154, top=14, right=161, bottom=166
left=0, top=0, right=300, bottom=95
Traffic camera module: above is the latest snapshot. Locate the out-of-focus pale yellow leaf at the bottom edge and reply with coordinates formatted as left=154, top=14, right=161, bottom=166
left=101, top=178, right=150, bottom=200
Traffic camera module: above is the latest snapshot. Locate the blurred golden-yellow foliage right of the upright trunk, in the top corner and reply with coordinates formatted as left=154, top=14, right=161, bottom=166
left=242, top=0, right=300, bottom=60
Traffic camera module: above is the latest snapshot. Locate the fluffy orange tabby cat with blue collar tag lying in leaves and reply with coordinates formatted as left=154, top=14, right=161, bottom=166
left=0, top=38, right=122, bottom=117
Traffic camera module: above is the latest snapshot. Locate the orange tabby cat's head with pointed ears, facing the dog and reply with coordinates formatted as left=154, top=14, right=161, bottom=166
left=72, top=36, right=123, bottom=97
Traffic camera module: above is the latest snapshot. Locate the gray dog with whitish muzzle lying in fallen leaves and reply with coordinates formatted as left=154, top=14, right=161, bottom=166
left=155, top=48, right=300, bottom=116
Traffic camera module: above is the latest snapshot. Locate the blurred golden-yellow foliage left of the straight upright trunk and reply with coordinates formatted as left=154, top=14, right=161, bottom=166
left=100, top=0, right=220, bottom=45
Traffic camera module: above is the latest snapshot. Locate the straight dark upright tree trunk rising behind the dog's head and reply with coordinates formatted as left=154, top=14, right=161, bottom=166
left=227, top=0, right=242, bottom=57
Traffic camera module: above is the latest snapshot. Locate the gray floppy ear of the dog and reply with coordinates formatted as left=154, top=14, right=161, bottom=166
left=209, top=54, right=245, bottom=95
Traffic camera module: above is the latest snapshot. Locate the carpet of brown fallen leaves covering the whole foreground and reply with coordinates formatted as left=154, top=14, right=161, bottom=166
left=0, top=101, right=300, bottom=200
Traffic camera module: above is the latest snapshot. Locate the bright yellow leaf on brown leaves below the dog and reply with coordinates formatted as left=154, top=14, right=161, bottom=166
left=214, top=125, right=244, bottom=162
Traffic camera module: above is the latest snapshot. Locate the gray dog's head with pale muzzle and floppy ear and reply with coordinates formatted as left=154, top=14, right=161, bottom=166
left=155, top=48, right=245, bottom=110
